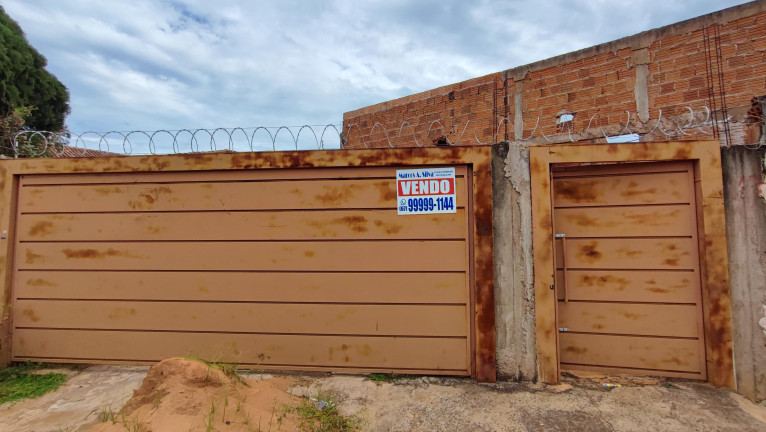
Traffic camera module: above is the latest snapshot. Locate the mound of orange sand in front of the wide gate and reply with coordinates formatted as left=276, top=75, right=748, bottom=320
left=88, top=358, right=300, bottom=432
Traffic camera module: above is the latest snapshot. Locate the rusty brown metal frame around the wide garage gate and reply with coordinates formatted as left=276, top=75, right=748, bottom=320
left=0, top=146, right=496, bottom=382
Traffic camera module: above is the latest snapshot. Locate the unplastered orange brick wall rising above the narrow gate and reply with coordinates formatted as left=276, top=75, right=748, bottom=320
left=344, top=2, right=766, bottom=148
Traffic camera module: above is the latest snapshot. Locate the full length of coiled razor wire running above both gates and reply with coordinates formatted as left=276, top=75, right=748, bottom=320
left=13, top=106, right=756, bottom=157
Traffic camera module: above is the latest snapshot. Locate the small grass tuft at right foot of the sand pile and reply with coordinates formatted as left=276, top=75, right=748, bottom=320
left=292, top=393, right=360, bottom=432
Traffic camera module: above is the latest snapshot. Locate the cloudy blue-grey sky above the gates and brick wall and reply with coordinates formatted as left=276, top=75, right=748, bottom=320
left=0, top=0, right=744, bottom=152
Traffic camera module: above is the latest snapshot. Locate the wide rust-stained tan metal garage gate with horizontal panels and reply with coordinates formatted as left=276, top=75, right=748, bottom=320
left=0, top=151, right=494, bottom=380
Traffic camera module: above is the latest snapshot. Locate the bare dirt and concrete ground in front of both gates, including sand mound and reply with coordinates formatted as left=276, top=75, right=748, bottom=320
left=0, top=359, right=766, bottom=432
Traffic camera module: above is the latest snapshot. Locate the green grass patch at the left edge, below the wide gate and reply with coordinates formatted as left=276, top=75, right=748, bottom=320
left=0, top=362, right=66, bottom=404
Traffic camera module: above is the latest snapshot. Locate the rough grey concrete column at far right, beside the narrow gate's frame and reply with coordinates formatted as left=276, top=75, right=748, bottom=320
left=722, top=146, right=766, bottom=401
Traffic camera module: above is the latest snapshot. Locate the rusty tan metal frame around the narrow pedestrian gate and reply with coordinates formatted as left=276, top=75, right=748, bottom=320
left=529, top=141, right=735, bottom=388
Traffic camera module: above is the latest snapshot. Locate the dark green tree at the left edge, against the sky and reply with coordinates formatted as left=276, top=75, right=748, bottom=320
left=0, top=6, right=69, bottom=153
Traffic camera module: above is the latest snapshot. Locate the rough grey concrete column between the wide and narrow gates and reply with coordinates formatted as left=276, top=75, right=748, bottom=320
left=492, top=143, right=537, bottom=380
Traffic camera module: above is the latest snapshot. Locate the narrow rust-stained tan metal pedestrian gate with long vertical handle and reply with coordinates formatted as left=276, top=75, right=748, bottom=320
left=552, top=162, right=707, bottom=379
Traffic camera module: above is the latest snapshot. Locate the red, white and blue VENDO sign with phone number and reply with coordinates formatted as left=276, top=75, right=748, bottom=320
left=396, top=167, right=457, bottom=215
